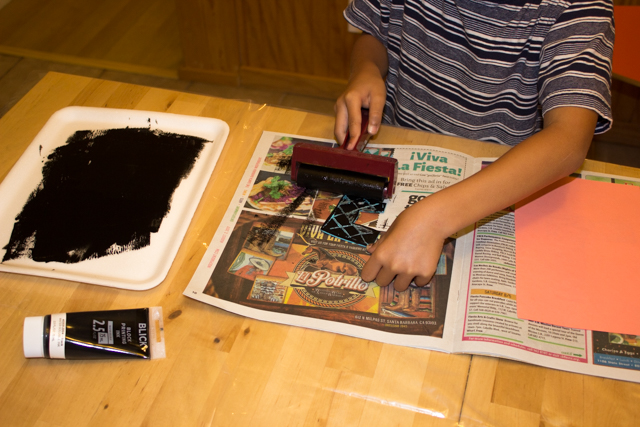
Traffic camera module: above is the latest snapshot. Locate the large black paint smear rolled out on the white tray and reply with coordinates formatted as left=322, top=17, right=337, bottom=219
left=3, top=128, right=207, bottom=263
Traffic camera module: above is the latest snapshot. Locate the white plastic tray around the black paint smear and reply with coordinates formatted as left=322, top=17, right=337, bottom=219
left=0, top=107, right=229, bottom=290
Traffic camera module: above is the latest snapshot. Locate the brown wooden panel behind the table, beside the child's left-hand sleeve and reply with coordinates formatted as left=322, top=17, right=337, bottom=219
left=176, top=0, right=357, bottom=97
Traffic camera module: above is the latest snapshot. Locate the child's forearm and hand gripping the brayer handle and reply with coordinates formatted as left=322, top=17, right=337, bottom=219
left=334, top=34, right=389, bottom=148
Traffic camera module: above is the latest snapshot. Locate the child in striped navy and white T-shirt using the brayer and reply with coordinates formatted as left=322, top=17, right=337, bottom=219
left=335, top=0, right=614, bottom=291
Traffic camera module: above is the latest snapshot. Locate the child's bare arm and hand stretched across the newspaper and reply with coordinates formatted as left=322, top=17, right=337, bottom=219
left=361, top=107, right=597, bottom=291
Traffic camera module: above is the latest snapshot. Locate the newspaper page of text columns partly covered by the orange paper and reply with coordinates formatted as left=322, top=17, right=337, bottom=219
left=455, top=166, right=640, bottom=381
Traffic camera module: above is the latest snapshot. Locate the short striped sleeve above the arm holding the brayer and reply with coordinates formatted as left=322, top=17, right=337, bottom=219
left=343, top=0, right=390, bottom=47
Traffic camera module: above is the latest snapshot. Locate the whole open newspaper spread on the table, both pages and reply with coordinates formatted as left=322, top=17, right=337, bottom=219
left=184, top=132, right=640, bottom=382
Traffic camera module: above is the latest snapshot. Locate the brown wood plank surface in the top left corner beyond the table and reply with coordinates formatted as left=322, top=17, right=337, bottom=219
left=0, top=0, right=182, bottom=78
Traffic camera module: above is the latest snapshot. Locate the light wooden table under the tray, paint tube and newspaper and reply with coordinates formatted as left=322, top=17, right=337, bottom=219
left=0, top=73, right=640, bottom=427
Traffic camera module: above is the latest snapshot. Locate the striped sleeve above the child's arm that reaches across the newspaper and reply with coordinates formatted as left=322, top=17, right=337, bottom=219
left=538, top=0, right=615, bottom=134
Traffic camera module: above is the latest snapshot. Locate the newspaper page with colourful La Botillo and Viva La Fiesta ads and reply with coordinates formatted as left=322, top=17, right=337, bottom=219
left=185, top=132, right=473, bottom=351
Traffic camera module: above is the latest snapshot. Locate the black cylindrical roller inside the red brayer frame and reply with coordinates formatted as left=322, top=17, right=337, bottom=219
left=296, top=164, right=387, bottom=200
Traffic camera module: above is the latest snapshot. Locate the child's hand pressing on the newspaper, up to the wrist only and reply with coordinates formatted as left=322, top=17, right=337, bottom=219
left=361, top=198, right=448, bottom=291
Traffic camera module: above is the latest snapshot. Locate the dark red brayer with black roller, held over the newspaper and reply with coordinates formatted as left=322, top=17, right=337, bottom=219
left=291, top=110, right=398, bottom=200
